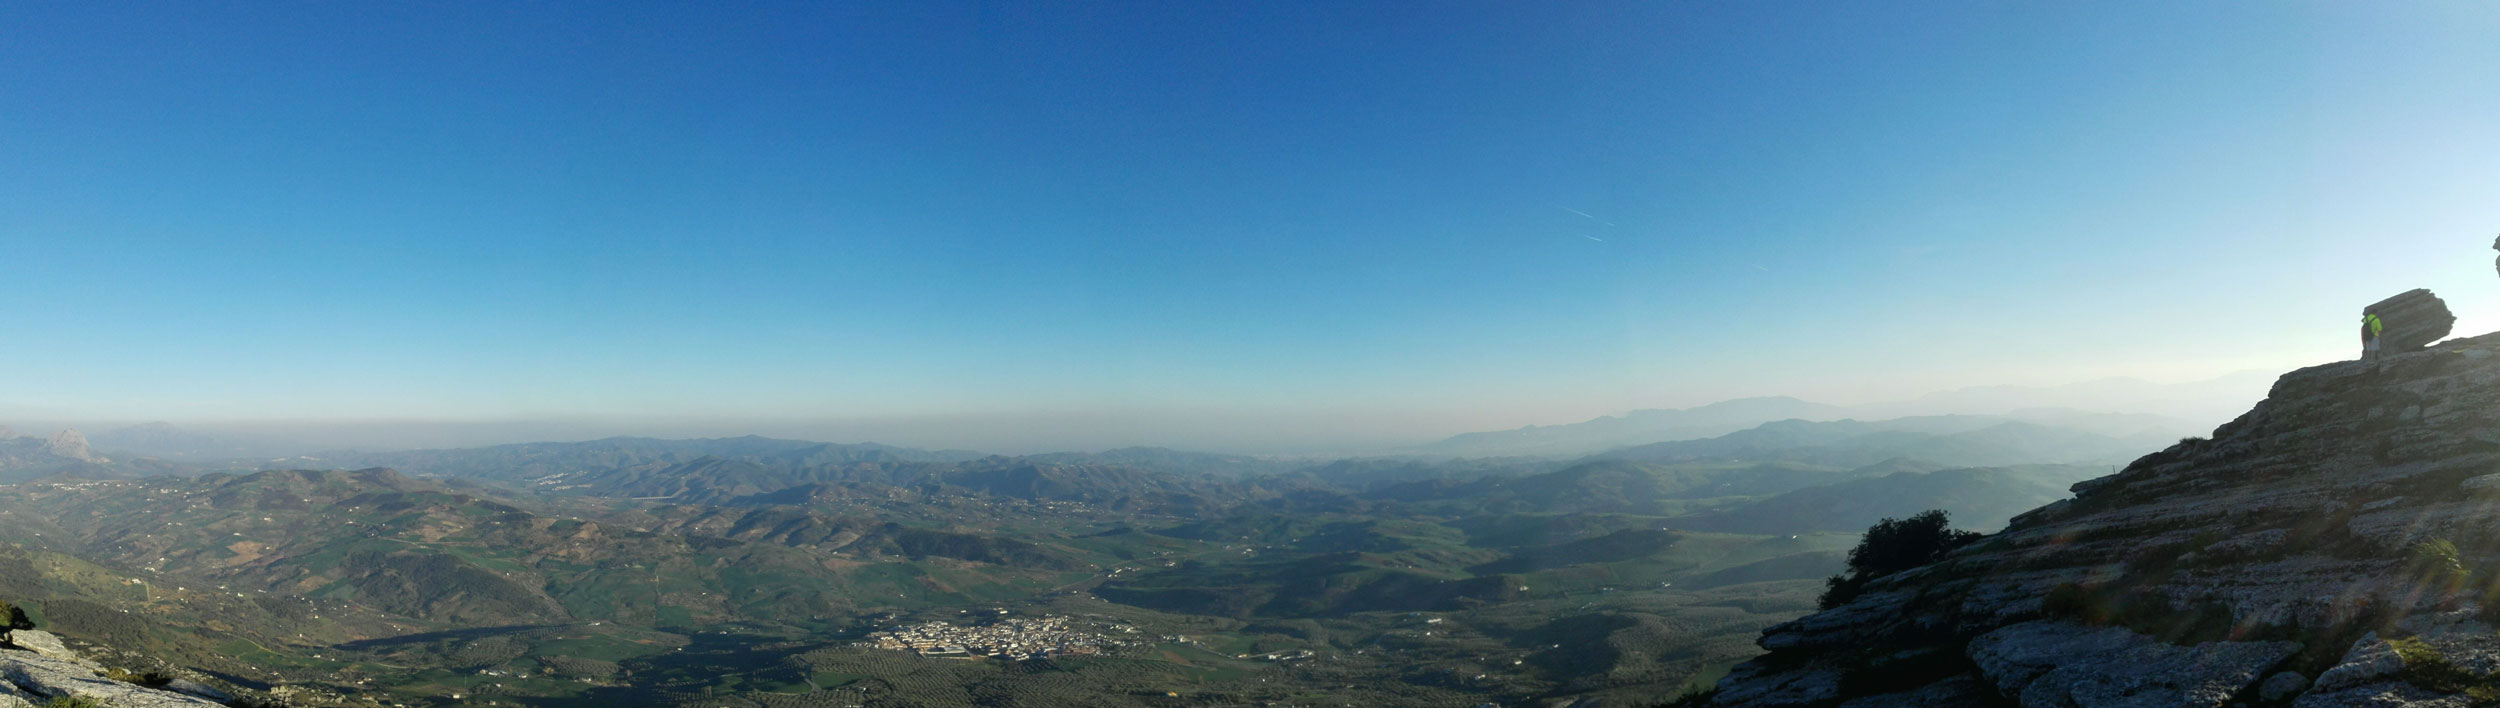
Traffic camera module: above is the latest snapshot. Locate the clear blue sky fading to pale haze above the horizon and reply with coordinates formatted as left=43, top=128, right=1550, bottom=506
left=0, top=3, right=2500, bottom=448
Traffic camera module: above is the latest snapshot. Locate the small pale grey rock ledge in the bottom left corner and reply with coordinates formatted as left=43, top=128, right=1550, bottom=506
left=0, top=630, right=225, bottom=708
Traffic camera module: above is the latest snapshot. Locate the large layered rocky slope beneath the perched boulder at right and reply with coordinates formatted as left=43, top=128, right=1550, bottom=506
left=1698, top=335, right=2500, bottom=708
